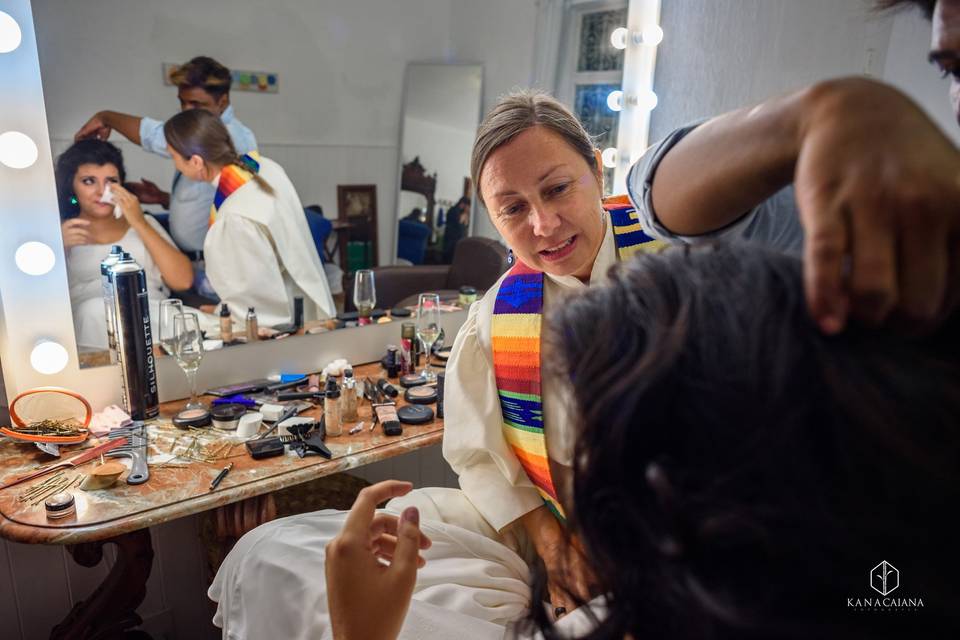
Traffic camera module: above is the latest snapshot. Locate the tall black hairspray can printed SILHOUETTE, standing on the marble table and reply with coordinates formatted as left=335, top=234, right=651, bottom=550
left=110, top=253, right=160, bottom=420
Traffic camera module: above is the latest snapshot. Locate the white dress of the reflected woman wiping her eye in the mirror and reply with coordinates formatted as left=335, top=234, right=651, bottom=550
left=66, top=214, right=176, bottom=350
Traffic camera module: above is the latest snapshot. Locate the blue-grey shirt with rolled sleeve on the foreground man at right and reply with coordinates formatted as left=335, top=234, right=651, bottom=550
left=627, top=122, right=803, bottom=254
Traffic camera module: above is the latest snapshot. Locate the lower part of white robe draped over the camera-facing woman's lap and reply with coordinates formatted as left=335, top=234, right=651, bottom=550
left=208, top=489, right=602, bottom=640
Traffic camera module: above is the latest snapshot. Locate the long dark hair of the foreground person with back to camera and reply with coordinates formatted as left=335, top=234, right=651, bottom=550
left=531, top=245, right=960, bottom=640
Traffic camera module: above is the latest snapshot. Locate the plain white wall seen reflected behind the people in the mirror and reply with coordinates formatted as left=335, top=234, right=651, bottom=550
left=34, top=0, right=535, bottom=263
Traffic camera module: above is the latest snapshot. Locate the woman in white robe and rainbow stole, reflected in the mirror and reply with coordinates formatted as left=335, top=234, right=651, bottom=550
left=163, top=109, right=336, bottom=326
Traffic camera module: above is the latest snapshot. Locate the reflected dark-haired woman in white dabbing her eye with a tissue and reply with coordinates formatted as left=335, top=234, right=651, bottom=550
left=56, top=140, right=193, bottom=349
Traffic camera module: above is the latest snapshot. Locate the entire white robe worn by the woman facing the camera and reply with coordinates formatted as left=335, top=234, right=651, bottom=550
left=208, top=224, right=617, bottom=640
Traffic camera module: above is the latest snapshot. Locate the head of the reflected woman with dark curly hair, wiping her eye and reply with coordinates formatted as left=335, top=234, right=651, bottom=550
left=56, top=139, right=127, bottom=220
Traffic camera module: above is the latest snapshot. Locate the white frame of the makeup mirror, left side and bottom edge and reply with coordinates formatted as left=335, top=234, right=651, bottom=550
left=0, top=0, right=467, bottom=408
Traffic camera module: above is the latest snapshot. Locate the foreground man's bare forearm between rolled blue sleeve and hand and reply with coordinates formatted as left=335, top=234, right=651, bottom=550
left=652, top=83, right=809, bottom=235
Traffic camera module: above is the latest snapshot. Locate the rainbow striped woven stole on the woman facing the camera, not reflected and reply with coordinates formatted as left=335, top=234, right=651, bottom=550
left=491, top=196, right=666, bottom=521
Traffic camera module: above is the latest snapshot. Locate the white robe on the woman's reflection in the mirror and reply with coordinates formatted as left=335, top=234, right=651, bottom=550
left=203, top=157, right=336, bottom=326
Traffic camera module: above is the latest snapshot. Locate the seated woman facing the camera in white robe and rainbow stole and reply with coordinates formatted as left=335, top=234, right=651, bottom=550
left=209, top=91, right=795, bottom=639
